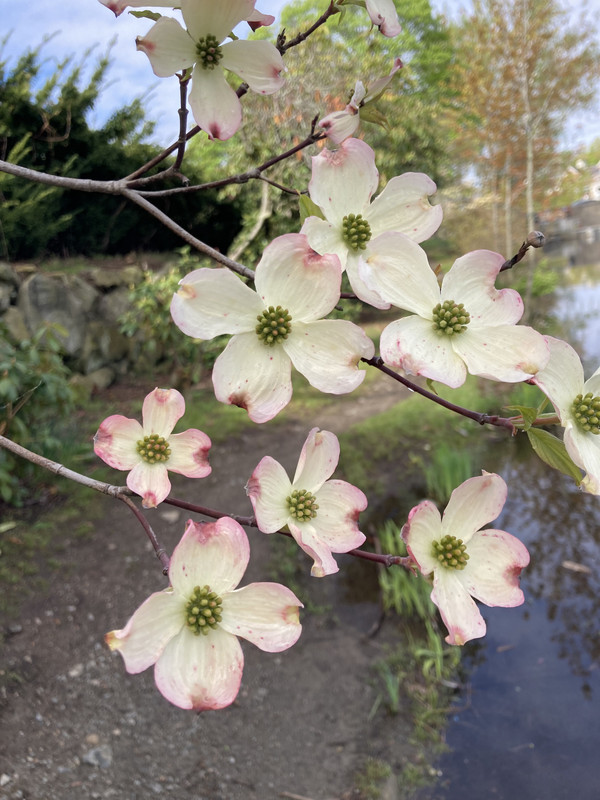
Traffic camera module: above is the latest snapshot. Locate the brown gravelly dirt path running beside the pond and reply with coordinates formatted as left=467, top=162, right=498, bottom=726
left=0, top=380, right=422, bottom=800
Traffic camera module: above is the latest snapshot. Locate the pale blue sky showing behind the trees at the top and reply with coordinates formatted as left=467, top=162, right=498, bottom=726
left=0, top=0, right=600, bottom=148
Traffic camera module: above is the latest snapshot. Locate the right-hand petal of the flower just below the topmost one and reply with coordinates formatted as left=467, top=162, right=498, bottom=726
left=365, top=177, right=443, bottom=242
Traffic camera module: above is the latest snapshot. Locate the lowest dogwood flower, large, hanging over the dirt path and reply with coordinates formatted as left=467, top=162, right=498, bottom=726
left=105, top=517, right=302, bottom=711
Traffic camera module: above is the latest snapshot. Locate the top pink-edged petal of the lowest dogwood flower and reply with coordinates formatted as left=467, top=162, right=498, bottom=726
left=169, top=517, right=250, bottom=599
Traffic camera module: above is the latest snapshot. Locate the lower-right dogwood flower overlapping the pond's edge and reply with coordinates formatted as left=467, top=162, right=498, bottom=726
left=402, top=472, right=529, bottom=644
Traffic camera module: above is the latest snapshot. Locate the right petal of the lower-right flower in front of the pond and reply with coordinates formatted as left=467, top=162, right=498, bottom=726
left=457, top=530, right=529, bottom=608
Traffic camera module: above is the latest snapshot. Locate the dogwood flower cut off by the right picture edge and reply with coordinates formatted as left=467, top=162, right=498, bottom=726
left=533, top=336, right=600, bottom=495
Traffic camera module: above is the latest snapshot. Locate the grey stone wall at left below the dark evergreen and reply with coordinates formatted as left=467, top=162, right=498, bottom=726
left=0, top=262, right=143, bottom=385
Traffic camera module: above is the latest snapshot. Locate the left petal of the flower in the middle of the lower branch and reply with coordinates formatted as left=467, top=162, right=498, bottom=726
left=246, top=456, right=292, bottom=533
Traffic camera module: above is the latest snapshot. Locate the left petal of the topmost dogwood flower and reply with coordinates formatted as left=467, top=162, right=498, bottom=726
left=135, top=17, right=196, bottom=78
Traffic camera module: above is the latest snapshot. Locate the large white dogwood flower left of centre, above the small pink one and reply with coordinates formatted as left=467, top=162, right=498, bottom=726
left=171, top=233, right=374, bottom=422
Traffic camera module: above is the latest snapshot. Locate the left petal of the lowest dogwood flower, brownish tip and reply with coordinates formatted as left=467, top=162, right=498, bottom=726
left=105, top=589, right=185, bottom=675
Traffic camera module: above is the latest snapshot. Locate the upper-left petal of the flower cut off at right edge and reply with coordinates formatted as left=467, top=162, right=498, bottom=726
left=533, top=336, right=584, bottom=418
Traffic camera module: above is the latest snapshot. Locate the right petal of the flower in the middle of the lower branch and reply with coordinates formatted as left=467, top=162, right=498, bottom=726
left=311, top=481, right=368, bottom=553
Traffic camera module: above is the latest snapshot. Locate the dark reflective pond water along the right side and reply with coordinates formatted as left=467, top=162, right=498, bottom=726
left=420, top=255, right=600, bottom=800
